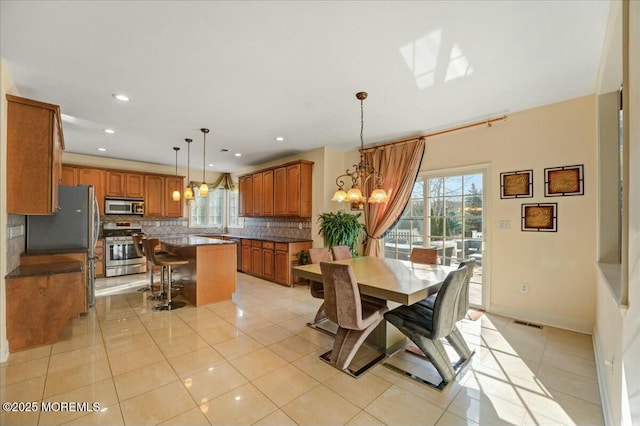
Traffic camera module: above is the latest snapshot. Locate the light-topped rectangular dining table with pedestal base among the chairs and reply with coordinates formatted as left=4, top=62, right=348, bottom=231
left=292, top=256, right=455, bottom=355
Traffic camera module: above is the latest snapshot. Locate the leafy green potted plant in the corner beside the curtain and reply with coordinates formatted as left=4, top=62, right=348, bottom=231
left=318, top=211, right=364, bottom=257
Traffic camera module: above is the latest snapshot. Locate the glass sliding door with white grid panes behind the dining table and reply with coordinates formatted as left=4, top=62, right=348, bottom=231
left=384, top=170, right=485, bottom=307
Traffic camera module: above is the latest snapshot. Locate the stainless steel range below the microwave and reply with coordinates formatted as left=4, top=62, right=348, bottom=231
left=102, top=222, right=147, bottom=277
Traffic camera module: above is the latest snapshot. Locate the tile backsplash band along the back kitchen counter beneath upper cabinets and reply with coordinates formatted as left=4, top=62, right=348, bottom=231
left=101, top=215, right=312, bottom=240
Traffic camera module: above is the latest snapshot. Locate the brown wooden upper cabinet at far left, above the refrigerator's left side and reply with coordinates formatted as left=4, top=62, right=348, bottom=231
left=6, top=95, right=64, bottom=214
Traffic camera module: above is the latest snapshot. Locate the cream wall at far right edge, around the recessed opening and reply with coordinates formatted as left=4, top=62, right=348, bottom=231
left=594, top=1, right=640, bottom=426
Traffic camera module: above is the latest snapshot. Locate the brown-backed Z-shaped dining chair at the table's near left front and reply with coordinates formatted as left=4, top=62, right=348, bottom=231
left=320, top=262, right=389, bottom=377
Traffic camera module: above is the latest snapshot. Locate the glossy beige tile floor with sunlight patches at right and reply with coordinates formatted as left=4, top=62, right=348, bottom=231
left=0, top=274, right=603, bottom=426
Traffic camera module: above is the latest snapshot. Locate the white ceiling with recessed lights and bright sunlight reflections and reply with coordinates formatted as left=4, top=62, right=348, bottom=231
left=0, top=0, right=610, bottom=171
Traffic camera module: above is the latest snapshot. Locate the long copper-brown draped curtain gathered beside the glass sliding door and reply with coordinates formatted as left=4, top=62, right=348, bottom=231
left=364, top=138, right=425, bottom=257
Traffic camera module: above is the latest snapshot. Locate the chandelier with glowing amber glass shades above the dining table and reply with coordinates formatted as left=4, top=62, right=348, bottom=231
left=331, top=92, right=389, bottom=209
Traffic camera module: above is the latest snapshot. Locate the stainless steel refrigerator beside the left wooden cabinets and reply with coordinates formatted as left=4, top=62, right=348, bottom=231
left=27, top=185, right=100, bottom=306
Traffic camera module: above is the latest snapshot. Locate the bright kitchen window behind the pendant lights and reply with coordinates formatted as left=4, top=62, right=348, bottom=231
left=189, top=186, right=242, bottom=228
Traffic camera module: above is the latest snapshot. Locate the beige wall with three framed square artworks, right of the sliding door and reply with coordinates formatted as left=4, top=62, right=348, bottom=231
left=422, top=96, right=596, bottom=333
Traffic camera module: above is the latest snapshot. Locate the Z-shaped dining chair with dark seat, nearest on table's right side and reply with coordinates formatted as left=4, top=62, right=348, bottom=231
left=384, top=266, right=471, bottom=390
